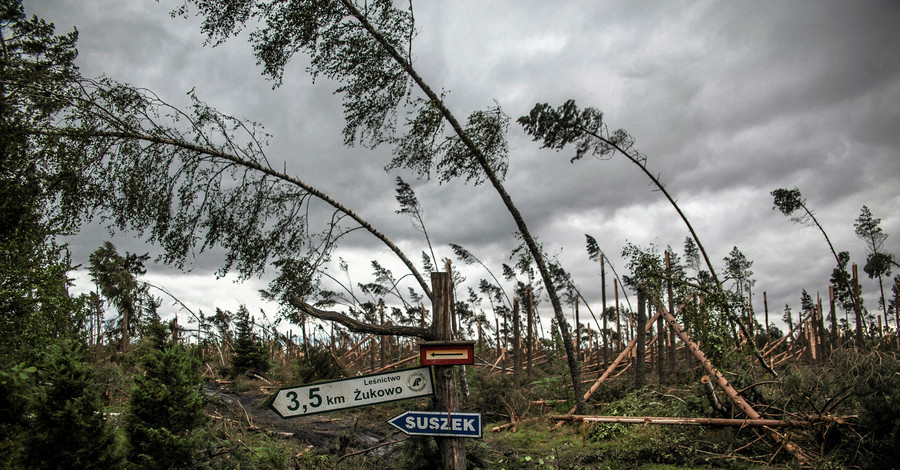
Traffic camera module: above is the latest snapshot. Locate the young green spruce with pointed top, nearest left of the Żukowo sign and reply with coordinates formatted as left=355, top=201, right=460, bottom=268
left=125, top=321, right=203, bottom=468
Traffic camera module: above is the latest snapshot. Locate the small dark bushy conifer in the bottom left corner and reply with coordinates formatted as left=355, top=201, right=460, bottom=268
left=25, top=341, right=121, bottom=469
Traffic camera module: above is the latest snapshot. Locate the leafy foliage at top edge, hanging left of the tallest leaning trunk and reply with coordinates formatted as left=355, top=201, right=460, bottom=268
left=178, top=0, right=414, bottom=146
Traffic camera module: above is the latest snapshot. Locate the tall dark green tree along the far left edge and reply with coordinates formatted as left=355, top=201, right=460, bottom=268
left=0, top=0, right=89, bottom=361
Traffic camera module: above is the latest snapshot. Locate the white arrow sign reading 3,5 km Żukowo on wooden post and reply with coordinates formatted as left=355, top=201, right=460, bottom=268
left=269, top=367, right=434, bottom=418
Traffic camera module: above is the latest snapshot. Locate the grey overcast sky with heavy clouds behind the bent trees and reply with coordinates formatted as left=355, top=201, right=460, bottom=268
left=26, top=0, right=900, bottom=338
